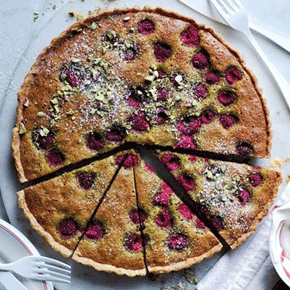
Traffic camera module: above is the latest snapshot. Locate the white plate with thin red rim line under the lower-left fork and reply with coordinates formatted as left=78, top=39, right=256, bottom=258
left=0, top=219, right=53, bottom=290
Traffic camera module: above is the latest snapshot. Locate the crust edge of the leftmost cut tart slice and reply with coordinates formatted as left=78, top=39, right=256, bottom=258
left=17, top=190, right=72, bottom=258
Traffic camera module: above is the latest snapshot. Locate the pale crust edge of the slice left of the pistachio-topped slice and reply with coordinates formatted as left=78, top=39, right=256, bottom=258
left=148, top=243, right=222, bottom=274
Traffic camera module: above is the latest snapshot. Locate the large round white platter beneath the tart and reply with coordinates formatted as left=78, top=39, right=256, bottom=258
left=0, top=0, right=290, bottom=290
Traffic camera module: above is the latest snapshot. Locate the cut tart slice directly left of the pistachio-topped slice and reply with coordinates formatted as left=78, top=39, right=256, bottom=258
left=134, top=160, right=222, bottom=274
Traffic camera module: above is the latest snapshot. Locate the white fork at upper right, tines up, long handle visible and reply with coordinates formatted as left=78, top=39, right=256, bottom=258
left=210, top=0, right=290, bottom=109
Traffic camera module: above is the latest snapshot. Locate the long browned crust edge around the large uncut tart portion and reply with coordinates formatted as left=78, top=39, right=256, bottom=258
left=12, top=6, right=272, bottom=182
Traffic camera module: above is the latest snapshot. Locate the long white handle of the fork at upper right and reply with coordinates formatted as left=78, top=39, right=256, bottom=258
left=243, top=29, right=290, bottom=110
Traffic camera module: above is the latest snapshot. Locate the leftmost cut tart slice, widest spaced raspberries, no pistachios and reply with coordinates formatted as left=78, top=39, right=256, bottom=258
left=17, top=156, right=118, bottom=257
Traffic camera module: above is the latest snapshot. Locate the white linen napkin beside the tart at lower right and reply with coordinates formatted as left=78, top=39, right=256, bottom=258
left=197, top=182, right=290, bottom=290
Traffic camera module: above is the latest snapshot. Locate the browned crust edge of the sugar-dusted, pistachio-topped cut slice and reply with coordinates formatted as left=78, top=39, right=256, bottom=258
left=230, top=172, right=282, bottom=250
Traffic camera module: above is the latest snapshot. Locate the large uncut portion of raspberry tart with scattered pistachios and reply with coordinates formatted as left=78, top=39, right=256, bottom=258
left=13, top=8, right=271, bottom=182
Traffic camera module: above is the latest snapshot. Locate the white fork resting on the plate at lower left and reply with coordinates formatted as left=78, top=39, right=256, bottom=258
left=0, top=256, right=71, bottom=283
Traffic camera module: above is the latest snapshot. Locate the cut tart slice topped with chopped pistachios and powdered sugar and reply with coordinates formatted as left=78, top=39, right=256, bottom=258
left=158, top=152, right=282, bottom=249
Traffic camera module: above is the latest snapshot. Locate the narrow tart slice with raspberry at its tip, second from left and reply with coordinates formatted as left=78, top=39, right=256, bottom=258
left=73, top=154, right=146, bottom=277
